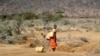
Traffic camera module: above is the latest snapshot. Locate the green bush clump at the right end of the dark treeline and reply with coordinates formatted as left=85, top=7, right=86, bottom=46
left=38, top=12, right=64, bottom=22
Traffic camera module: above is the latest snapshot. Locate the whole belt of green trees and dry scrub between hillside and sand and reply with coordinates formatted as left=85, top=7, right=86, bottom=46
left=0, top=12, right=100, bottom=43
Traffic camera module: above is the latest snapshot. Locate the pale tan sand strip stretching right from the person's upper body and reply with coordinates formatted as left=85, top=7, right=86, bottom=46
left=57, top=31, right=100, bottom=42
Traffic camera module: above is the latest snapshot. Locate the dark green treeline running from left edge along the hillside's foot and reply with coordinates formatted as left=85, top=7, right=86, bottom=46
left=0, top=12, right=65, bottom=21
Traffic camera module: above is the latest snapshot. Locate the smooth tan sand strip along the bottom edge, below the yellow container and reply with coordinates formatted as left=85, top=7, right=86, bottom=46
left=0, top=44, right=83, bottom=56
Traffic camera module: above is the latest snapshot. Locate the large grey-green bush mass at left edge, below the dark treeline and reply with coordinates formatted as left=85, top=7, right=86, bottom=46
left=0, top=16, right=21, bottom=44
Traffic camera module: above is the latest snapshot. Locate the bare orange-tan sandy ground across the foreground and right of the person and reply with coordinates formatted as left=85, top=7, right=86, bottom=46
left=0, top=31, right=100, bottom=56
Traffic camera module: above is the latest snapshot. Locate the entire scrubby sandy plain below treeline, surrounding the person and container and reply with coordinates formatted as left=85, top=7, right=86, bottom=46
left=0, top=18, right=100, bottom=56
